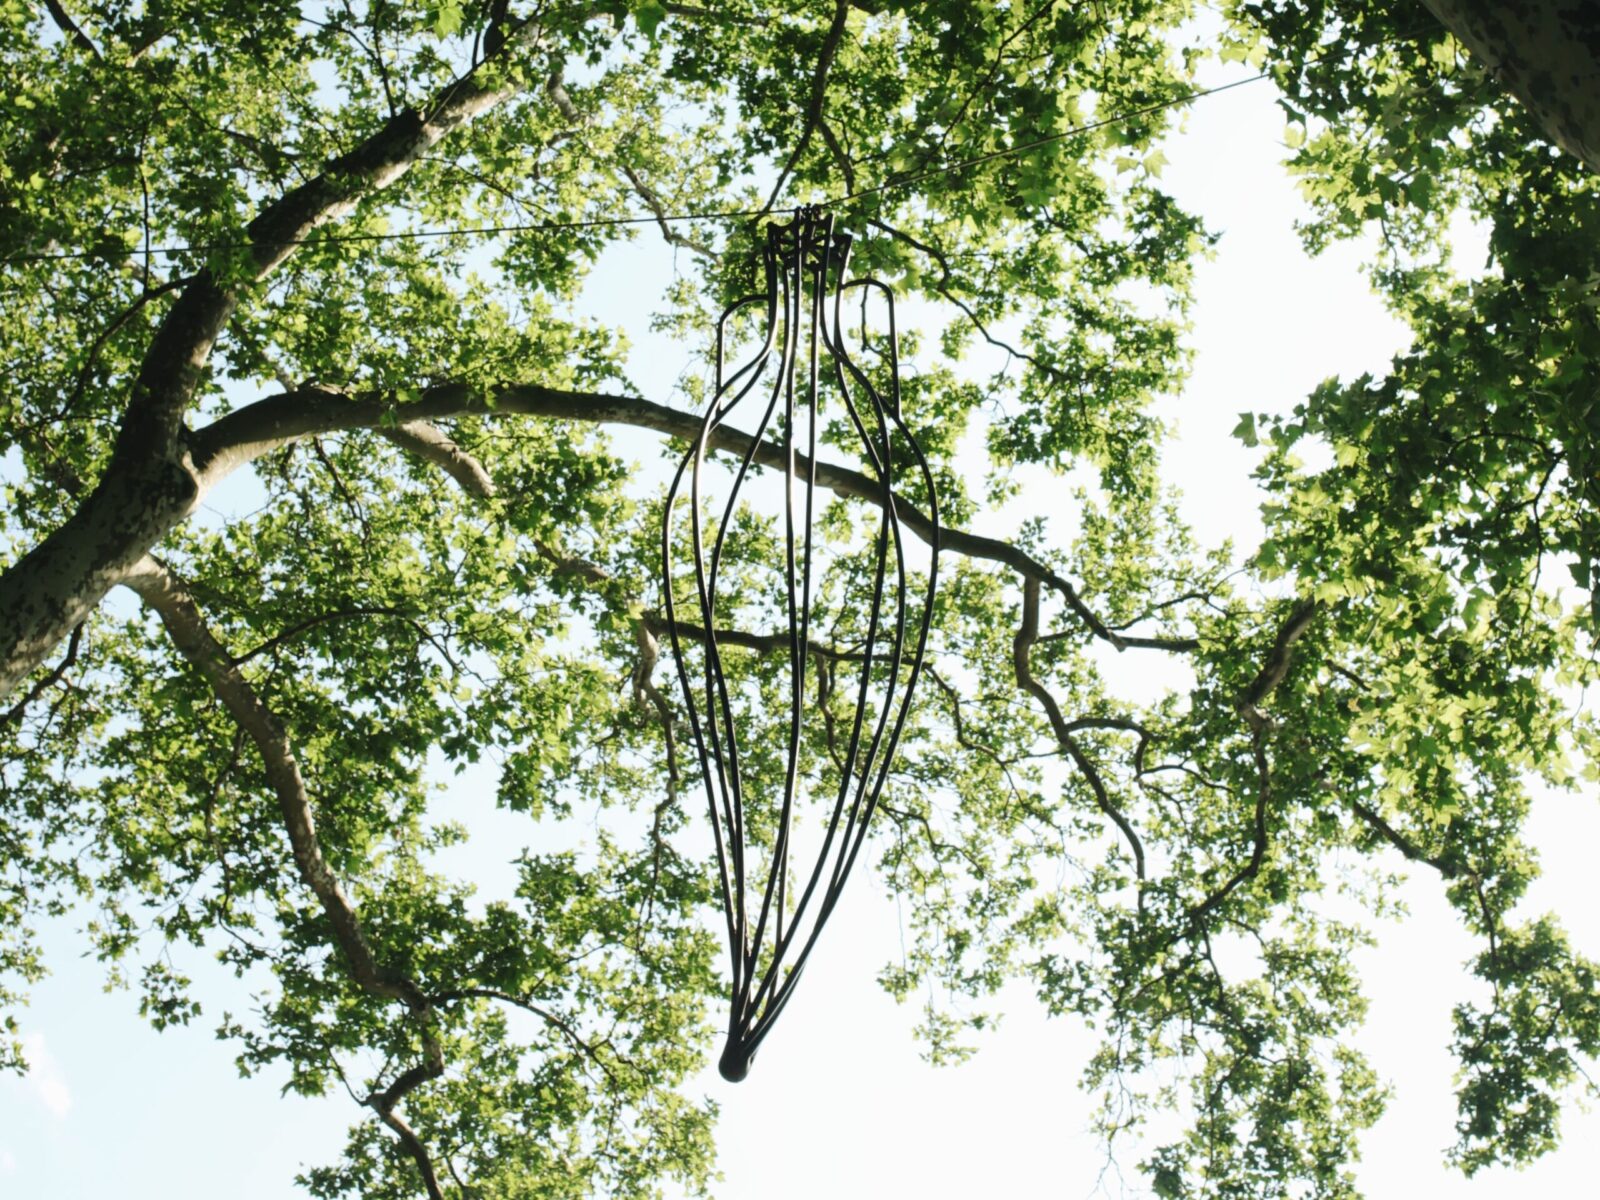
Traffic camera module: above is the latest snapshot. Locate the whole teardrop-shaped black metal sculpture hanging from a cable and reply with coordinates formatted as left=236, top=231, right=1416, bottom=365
left=661, top=208, right=939, bottom=1080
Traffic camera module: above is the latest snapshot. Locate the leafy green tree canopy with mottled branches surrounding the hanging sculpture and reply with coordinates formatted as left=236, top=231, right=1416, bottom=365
left=0, top=0, right=1600, bottom=1197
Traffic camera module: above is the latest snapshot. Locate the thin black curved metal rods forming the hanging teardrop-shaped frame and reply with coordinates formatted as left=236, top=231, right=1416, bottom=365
left=661, top=208, right=939, bottom=1080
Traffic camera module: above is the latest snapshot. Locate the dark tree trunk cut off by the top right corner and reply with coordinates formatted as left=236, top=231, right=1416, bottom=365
left=1422, top=0, right=1600, bottom=171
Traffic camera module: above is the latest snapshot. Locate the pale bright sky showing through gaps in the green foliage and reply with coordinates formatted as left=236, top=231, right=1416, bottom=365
left=0, top=28, right=1600, bottom=1200
